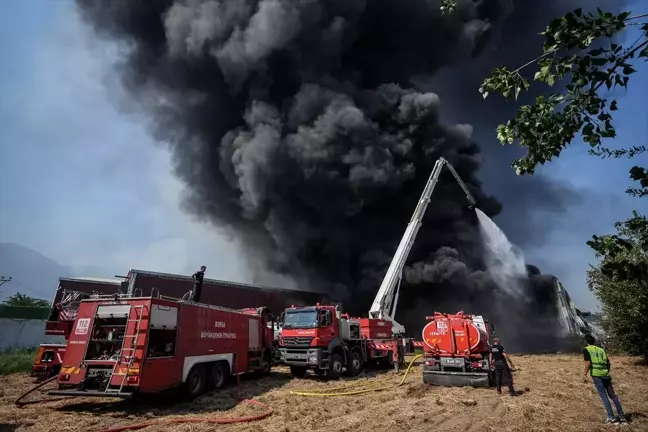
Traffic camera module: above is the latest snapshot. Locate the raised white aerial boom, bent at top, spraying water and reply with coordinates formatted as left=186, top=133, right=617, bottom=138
left=369, top=157, right=476, bottom=335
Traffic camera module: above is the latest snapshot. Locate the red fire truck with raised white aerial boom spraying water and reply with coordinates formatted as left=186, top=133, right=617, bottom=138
left=279, top=158, right=476, bottom=378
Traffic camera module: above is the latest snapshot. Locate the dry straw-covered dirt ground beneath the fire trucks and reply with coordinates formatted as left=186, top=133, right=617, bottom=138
left=0, top=355, right=648, bottom=432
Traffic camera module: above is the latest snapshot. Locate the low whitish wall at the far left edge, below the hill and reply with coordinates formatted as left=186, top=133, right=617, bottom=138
left=0, top=318, right=65, bottom=351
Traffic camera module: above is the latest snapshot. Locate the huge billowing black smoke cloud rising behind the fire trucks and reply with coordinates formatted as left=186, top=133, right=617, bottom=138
left=77, top=0, right=624, bottom=352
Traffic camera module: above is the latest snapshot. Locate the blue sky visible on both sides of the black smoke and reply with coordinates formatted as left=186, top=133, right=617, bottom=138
left=0, top=0, right=648, bottom=309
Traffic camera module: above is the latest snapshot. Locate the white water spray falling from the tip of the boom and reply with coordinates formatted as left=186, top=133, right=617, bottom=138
left=475, top=209, right=527, bottom=297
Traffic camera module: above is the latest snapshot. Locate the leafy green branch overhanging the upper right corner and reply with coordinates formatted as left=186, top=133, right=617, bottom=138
left=479, top=9, right=648, bottom=175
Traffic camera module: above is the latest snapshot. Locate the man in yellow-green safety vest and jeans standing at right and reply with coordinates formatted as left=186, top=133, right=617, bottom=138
left=583, top=335, right=627, bottom=426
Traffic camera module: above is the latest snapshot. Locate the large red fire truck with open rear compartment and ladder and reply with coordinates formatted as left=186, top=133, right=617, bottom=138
left=49, top=295, right=273, bottom=398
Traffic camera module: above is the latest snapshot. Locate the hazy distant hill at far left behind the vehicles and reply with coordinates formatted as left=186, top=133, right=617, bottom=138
left=0, top=243, right=113, bottom=302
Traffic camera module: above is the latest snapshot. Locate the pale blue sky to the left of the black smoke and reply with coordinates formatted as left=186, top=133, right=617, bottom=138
left=0, top=0, right=246, bottom=281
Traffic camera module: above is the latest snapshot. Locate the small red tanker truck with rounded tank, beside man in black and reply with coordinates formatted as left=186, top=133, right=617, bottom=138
left=423, top=312, right=495, bottom=387
